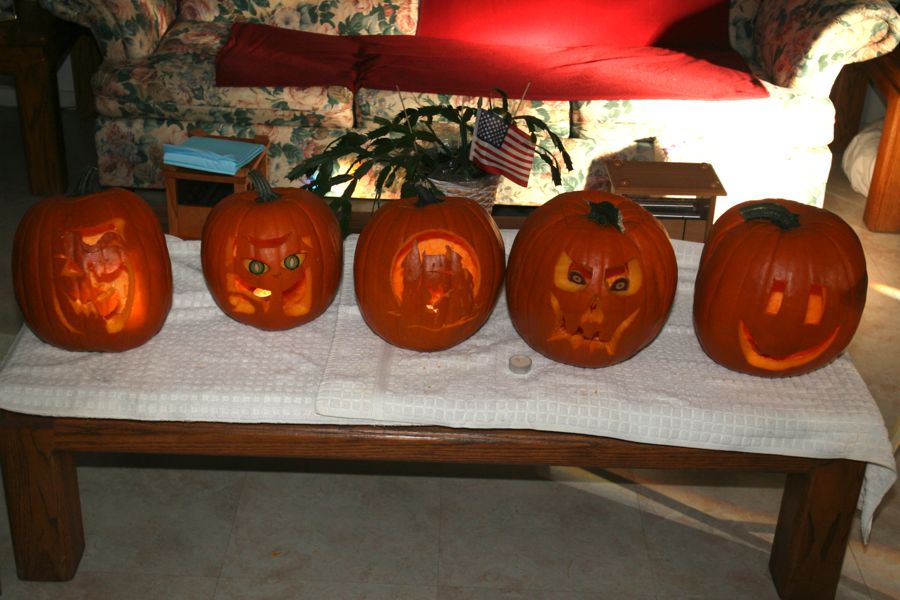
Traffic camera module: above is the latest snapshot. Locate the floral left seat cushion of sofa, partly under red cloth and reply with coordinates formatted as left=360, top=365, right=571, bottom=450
left=93, top=21, right=353, bottom=128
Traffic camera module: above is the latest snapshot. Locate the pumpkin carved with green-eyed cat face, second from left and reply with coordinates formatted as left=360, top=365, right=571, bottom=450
left=200, top=171, right=343, bottom=330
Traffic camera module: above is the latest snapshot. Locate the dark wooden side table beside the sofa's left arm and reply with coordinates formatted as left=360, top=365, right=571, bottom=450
left=0, top=0, right=100, bottom=195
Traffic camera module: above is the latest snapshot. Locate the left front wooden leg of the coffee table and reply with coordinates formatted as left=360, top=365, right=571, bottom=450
left=0, top=421, right=84, bottom=581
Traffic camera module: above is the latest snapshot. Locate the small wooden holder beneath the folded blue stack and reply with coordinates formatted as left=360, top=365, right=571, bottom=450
left=163, top=130, right=269, bottom=240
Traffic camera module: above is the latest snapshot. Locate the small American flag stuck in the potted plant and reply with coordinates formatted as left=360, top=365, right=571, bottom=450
left=469, top=108, right=534, bottom=187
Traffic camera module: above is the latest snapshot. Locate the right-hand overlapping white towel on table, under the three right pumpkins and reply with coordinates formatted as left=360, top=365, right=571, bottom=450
left=316, top=231, right=896, bottom=535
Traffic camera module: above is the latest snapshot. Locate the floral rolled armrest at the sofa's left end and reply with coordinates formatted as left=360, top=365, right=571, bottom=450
left=40, top=0, right=178, bottom=61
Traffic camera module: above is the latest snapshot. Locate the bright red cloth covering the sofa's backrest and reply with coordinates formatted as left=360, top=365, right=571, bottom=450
left=416, top=0, right=729, bottom=50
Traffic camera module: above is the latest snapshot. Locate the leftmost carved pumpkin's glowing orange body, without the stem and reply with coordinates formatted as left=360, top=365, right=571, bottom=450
left=12, top=188, right=172, bottom=352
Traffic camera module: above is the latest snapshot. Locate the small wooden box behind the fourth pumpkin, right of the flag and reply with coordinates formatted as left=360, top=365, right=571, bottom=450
left=606, top=160, right=726, bottom=242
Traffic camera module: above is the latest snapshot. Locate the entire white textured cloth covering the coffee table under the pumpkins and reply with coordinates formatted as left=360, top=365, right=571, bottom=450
left=0, top=232, right=897, bottom=537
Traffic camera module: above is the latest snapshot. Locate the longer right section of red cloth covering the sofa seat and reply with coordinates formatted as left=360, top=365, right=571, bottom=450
left=357, top=35, right=767, bottom=100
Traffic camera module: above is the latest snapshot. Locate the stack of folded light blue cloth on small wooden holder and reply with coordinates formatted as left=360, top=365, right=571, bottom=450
left=163, top=136, right=265, bottom=175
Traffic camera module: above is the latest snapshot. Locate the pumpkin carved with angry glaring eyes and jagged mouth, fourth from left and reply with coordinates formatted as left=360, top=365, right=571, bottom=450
left=506, top=190, right=678, bottom=367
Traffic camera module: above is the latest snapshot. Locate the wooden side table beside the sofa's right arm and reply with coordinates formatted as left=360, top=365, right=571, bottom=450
left=831, top=50, right=900, bottom=232
